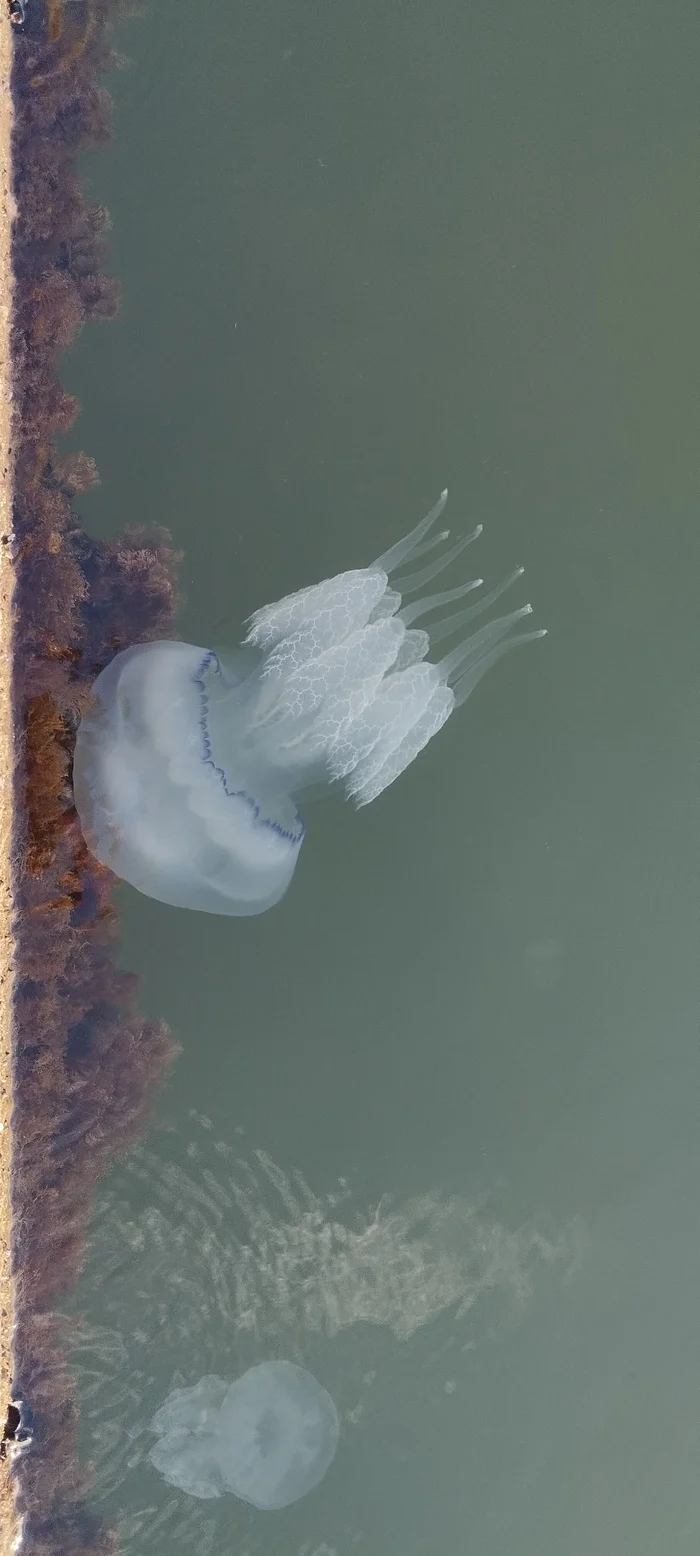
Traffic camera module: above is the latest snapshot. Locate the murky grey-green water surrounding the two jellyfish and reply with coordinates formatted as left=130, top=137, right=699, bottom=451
left=67, top=0, right=700, bottom=1556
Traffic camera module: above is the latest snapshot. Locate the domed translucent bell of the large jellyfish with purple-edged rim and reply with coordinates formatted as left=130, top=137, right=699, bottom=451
left=73, top=643, right=303, bottom=915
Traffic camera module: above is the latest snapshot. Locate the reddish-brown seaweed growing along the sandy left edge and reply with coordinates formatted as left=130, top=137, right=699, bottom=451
left=9, top=0, right=182, bottom=1556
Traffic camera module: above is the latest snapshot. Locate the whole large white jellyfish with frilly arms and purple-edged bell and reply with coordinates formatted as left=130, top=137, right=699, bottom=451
left=73, top=492, right=544, bottom=915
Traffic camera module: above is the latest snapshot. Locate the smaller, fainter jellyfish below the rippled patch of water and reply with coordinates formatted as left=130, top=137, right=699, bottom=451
left=149, top=1362, right=339, bottom=1508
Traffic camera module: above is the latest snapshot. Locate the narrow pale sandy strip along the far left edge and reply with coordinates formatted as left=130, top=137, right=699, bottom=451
left=0, top=3, right=17, bottom=1556
